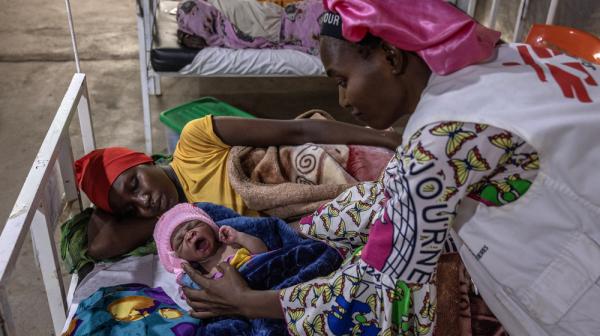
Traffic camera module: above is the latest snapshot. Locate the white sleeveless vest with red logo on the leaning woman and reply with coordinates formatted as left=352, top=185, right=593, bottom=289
left=404, top=44, right=600, bottom=336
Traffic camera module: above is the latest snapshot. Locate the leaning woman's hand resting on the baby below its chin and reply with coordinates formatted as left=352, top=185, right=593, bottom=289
left=183, top=262, right=252, bottom=319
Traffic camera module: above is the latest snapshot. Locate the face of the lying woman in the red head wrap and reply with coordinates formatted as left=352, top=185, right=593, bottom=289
left=108, top=164, right=179, bottom=218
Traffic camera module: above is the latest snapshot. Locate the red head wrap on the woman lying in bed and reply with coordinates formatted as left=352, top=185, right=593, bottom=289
left=75, top=147, right=152, bottom=212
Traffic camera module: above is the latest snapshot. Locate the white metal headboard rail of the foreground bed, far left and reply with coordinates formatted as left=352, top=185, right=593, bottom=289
left=0, top=73, right=95, bottom=335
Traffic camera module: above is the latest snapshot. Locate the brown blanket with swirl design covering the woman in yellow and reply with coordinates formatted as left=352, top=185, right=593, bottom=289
left=227, top=110, right=393, bottom=221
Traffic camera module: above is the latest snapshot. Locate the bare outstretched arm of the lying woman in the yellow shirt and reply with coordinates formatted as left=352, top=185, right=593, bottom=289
left=213, top=117, right=401, bottom=149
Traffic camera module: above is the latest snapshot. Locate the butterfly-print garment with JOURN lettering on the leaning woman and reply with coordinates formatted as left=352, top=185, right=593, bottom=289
left=280, top=122, right=539, bottom=335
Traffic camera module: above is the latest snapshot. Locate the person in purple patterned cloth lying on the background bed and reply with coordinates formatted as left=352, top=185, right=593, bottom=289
left=177, top=0, right=324, bottom=55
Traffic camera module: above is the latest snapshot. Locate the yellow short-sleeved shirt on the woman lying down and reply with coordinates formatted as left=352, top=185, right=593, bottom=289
left=171, top=116, right=259, bottom=216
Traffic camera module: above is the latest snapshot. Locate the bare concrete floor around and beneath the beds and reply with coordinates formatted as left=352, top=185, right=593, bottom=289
left=0, top=0, right=600, bottom=336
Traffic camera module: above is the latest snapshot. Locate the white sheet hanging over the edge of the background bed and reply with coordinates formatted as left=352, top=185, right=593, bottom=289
left=179, top=47, right=325, bottom=76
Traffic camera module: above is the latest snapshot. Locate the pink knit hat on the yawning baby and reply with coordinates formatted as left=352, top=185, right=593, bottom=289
left=154, top=203, right=219, bottom=275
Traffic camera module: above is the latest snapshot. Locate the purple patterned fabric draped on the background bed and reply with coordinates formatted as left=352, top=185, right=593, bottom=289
left=177, top=0, right=324, bottom=55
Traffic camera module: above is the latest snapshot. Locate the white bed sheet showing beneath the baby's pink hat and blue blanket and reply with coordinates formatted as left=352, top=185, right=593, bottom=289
left=63, top=255, right=190, bottom=332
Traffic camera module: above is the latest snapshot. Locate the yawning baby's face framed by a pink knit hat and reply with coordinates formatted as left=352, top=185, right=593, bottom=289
left=171, top=220, right=220, bottom=262
